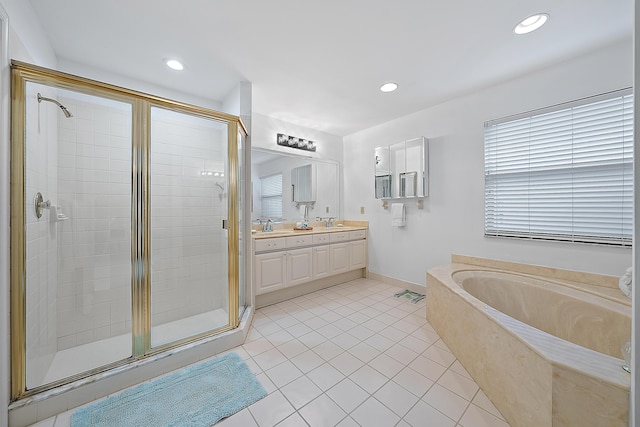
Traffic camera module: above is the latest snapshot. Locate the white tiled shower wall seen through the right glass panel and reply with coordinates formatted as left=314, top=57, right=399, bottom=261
left=151, top=112, right=227, bottom=326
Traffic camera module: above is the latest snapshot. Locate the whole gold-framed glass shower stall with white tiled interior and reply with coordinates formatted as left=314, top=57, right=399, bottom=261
left=11, top=62, right=246, bottom=399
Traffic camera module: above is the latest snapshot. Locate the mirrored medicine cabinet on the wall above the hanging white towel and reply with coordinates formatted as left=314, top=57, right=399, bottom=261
left=375, top=137, right=429, bottom=199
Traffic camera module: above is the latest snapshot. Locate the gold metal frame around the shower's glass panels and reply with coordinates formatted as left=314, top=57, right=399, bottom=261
left=10, top=61, right=247, bottom=401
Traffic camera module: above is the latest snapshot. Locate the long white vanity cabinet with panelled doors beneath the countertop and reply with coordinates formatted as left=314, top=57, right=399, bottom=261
left=254, top=230, right=367, bottom=295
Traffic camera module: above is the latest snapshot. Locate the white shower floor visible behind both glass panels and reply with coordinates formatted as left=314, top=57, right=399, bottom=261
left=43, top=308, right=229, bottom=384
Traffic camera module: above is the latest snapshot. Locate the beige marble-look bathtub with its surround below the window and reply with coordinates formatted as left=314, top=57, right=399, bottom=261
left=427, top=255, right=631, bottom=427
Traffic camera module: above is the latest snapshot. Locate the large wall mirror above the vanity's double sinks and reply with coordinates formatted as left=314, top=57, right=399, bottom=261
left=251, top=148, right=340, bottom=221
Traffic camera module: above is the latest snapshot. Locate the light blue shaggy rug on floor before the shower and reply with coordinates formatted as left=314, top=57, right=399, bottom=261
left=71, top=353, right=267, bottom=427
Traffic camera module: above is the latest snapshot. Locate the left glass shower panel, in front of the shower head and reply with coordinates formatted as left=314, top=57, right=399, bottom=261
left=24, top=82, right=132, bottom=390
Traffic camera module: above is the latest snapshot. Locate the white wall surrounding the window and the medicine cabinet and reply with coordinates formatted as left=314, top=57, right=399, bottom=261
left=344, top=40, right=633, bottom=286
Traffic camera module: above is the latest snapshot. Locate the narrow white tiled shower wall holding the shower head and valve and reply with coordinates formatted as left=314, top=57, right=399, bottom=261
left=25, top=85, right=59, bottom=387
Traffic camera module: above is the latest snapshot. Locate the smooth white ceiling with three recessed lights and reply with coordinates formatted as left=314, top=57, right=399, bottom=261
left=30, top=0, right=633, bottom=135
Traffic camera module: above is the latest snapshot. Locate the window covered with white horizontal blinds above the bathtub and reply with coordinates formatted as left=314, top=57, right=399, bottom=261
left=484, top=90, right=633, bottom=246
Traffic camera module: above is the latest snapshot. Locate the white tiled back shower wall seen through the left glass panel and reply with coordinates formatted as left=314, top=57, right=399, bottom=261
left=57, top=98, right=131, bottom=350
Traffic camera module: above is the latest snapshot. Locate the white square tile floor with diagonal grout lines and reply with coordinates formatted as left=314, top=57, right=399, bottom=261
left=35, top=279, right=509, bottom=427
